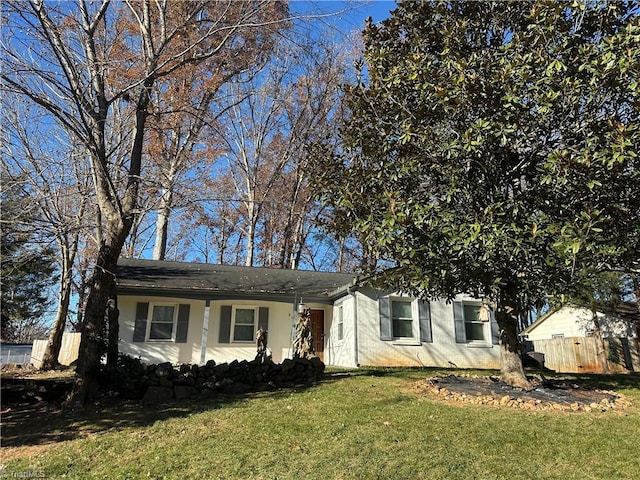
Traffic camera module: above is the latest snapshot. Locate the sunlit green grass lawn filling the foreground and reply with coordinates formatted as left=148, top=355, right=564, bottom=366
left=0, top=369, right=640, bottom=480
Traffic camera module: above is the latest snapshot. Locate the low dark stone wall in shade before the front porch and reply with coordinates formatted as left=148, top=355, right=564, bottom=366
left=101, top=356, right=325, bottom=404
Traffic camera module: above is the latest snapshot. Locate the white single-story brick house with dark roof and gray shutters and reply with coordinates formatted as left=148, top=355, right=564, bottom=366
left=117, top=259, right=500, bottom=368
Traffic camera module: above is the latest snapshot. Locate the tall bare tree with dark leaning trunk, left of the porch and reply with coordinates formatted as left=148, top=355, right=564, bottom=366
left=2, top=0, right=287, bottom=402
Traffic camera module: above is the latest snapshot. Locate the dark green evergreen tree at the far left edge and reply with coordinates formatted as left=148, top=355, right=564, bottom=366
left=0, top=176, right=56, bottom=343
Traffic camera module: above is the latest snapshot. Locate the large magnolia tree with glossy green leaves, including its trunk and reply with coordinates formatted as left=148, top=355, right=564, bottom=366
left=316, top=1, right=640, bottom=387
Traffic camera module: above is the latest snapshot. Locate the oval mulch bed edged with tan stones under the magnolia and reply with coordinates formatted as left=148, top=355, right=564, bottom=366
left=410, top=375, right=631, bottom=412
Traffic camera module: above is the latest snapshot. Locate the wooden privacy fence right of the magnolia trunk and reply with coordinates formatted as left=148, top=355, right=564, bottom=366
left=533, top=337, right=640, bottom=373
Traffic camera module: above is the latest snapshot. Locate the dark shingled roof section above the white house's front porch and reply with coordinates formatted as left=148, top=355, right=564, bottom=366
left=116, top=258, right=356, bottom=301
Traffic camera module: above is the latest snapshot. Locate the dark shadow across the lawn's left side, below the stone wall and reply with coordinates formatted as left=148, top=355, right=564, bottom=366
left=0, top=374, right=348, bottom=447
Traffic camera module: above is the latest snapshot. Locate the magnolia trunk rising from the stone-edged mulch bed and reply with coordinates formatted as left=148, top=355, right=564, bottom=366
left=496, top=290, right=532, bottom=390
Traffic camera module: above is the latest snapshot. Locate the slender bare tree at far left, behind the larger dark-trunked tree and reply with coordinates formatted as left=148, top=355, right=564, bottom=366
left=3, top=99, right=95, bottom=370
